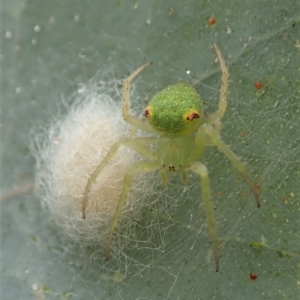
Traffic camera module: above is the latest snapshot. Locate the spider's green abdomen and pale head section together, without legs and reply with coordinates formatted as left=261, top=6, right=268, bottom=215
left=145, top=83, right=203, bottom=178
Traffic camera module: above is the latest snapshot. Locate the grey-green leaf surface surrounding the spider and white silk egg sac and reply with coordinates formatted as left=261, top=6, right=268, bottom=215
left=0, top=0, right=300, bottom=300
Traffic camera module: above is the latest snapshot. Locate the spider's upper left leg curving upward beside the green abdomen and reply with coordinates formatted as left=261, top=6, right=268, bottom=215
left=122, top=62, right=154, bottom=135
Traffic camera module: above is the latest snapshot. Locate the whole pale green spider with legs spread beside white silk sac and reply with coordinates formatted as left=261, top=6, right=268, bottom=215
left=82, top=43, right=260, bottom=272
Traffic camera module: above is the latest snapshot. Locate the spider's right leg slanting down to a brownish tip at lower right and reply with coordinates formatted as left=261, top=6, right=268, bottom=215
left=202, top=124, right=260, bottom=207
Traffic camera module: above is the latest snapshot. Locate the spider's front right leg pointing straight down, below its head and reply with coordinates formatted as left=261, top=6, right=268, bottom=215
left=191, top=161, right=219, bottom=272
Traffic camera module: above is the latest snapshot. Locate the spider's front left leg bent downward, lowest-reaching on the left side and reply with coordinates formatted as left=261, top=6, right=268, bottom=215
left=105, top=161, right=159, bottom=260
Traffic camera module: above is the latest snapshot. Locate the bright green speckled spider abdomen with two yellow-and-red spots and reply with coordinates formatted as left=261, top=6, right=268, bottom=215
left=145, top=83, right=202, bottom=135
